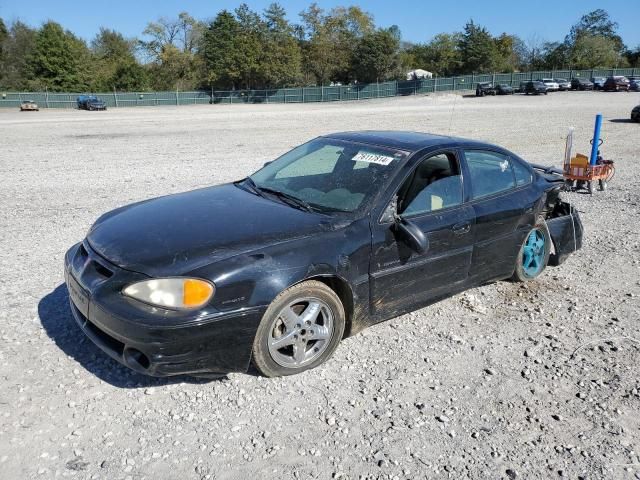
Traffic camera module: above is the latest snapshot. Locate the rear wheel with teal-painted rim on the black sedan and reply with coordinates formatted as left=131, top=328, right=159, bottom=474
left=511, top=218, right=551, bottom=282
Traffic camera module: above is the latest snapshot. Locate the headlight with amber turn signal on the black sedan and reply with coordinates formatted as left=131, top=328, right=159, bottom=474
left=122, top=278, right=215, bottom=308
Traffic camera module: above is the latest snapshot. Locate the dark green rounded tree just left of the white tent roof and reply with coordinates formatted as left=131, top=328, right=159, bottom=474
left=353, top=29, right=400, bottom=83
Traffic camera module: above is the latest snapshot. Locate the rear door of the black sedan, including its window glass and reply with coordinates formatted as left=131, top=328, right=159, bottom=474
left=464, top=149, right=538, bottom=283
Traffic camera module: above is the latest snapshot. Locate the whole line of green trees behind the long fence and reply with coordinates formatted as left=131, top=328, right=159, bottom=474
left=0, top=3, right=640, bottom=92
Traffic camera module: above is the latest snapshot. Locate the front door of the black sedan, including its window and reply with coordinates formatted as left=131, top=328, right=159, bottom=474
left=370, top=151, right=475, bottom=320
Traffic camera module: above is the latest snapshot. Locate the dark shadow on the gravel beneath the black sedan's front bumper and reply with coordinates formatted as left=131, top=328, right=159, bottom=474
left=38, top=284, right=226, bottom=388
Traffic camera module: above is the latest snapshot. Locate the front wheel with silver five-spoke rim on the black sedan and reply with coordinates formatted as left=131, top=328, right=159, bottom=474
left=253, top=280, right=346, bottom=377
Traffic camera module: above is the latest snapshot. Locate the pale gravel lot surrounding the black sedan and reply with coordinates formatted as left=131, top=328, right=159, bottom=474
left=0, top=92, right=640, bottom=480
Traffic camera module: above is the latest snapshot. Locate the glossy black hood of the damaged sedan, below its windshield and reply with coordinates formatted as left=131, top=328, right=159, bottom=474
left=87, top=184, right=332, bottom=277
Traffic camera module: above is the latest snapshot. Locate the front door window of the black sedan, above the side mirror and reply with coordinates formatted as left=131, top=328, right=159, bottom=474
left=398, top=152, right=462, bottom=216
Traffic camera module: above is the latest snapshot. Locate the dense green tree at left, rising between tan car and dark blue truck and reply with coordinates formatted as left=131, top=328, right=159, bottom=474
left=28, top=21, right=91, bottom=91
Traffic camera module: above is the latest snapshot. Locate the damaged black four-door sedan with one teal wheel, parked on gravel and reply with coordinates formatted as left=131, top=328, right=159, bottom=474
left=65, top=132, right=582, bottom=376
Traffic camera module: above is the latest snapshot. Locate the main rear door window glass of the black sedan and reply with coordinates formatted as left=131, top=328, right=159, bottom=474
left=464, top=150, right=516, bottom=199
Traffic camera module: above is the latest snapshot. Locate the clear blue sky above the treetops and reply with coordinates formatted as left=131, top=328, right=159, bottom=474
left=0, top=0, right=640, bottom=47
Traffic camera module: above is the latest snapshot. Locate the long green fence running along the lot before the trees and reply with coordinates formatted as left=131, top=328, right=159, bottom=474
left=0, top=68, right=640, bottom=108
